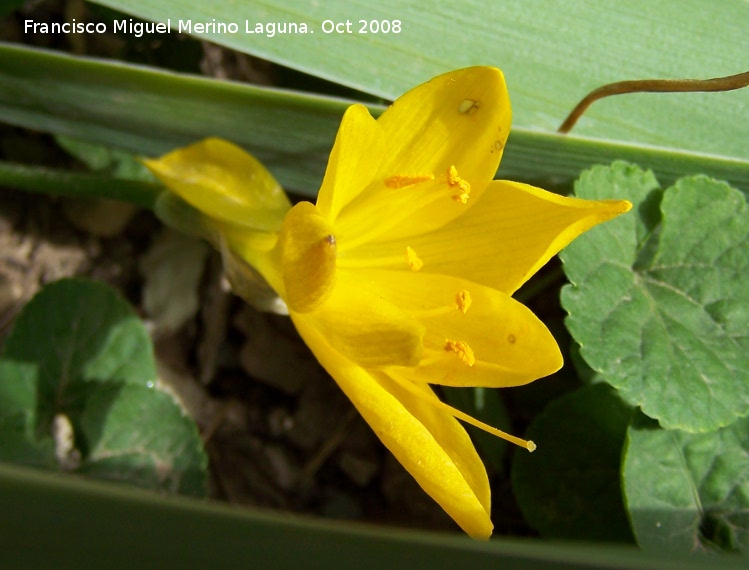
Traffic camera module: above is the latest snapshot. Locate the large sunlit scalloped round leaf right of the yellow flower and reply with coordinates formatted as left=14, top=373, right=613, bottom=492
left=561, top=163, right=749, bottom=432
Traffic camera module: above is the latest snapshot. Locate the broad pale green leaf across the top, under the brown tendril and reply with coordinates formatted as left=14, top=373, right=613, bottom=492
left=93, top=0, right=749, bottom=163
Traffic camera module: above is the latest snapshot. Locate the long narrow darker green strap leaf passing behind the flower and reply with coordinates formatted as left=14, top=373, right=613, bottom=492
left=0, top=43, right=749, bottom=197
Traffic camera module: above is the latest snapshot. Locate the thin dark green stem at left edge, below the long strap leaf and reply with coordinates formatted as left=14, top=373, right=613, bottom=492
left=0, top=161, right=163, bottom=210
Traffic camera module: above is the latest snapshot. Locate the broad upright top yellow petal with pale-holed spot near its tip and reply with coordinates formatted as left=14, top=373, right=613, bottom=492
left=335, top=67, right=511, bottom=247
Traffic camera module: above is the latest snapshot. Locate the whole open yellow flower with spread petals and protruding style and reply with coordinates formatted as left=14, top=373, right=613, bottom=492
left=143, top=67, right=630, bottom=538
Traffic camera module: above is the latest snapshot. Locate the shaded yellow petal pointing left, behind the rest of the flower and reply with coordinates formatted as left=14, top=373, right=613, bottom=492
left=143, top=138, right=291, bottom=231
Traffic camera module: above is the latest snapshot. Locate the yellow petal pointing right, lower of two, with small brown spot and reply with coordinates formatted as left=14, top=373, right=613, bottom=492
left=360, top=270, right=562, bottom=388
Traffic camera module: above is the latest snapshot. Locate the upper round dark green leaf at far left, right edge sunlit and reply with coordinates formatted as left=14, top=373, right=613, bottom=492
left=0, top=279, right=156, bottom=406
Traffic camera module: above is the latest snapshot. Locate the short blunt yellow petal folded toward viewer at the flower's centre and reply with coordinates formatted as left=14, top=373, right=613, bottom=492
left=309, top=271, right=424, bottom=368
